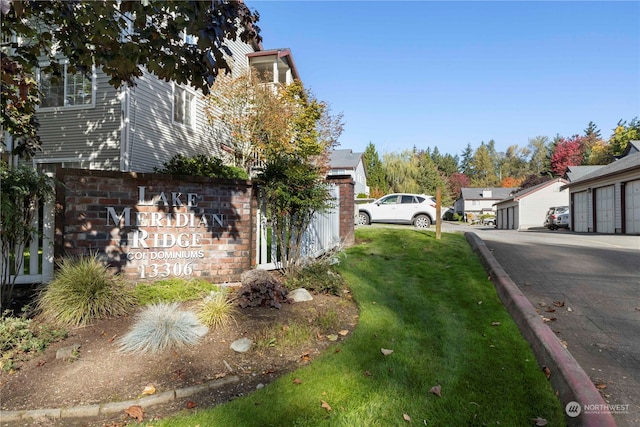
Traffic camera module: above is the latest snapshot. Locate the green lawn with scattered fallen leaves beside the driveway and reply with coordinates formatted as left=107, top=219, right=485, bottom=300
left=149, top=227, right=565, bottom=427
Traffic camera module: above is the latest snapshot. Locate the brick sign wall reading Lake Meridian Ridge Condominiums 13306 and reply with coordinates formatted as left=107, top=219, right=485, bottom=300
left=55, top=169, right=257, bottom=283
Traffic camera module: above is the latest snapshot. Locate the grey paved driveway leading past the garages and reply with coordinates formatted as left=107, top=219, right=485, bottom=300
left=466, top=227, right=640, bottom=426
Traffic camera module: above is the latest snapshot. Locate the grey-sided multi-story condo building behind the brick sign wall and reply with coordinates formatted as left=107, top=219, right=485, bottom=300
left=26, top=41, right=298, bottom=176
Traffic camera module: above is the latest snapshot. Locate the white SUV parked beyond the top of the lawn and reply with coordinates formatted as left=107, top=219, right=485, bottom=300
left=357, top=193, right=436, bottom=228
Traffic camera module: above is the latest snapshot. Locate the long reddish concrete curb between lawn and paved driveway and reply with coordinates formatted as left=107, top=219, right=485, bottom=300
left=464, top=232, right=616, bottom=427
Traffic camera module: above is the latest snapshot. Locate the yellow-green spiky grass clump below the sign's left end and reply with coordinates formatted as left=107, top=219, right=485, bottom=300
left=36, top=256, right=136, bottom=327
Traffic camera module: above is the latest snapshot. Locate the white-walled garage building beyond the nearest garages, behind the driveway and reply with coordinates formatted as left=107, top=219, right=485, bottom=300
left=495, top=178, right=569, bottom=230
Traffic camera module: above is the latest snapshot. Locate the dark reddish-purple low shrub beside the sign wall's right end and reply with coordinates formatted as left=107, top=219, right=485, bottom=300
left=238, top=270, right=289, bottom=308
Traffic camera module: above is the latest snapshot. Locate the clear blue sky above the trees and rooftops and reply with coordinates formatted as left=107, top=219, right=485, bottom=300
left=245, top=0, right=640, bottom=155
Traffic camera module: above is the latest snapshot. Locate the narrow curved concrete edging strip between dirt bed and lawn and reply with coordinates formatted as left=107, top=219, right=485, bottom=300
left=0, top=375, right=240, bottom=422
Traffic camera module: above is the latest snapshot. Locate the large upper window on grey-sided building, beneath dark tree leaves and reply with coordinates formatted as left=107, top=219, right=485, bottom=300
left=39, top=63, right=94, bottom=108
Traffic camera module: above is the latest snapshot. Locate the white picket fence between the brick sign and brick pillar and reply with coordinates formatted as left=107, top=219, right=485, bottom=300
left=256, top=185, right=340, bottom=270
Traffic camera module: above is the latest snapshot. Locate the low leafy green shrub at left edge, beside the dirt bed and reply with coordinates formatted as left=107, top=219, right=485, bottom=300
left=0, top=311, right=67, bottom=371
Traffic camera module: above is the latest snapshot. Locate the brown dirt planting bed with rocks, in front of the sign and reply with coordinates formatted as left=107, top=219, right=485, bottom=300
left=0, top=294, right=358, bottom=427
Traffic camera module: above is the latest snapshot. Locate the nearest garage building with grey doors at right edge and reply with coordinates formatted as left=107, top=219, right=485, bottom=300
left=562, top=141, right=640, bottom=235
